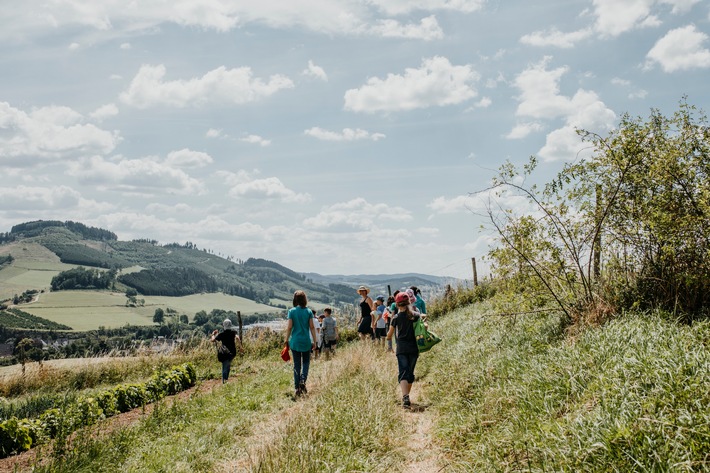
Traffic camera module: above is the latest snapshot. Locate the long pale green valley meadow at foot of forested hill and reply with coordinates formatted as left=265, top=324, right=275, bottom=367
left=14, top=291, right=280, bottom=331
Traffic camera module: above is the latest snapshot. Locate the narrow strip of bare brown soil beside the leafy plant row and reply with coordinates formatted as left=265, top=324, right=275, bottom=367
left=0, top=379, right=222, bottom=473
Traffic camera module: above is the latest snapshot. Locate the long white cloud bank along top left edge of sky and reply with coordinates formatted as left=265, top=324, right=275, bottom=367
left=0, top=0, right=485, bottom=44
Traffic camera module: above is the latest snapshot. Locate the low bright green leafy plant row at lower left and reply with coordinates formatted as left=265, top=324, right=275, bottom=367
left=0, top=363, right=197, bottom=458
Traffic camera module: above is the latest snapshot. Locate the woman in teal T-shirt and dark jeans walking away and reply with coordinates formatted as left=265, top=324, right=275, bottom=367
left=286, top=291, right=317, bottom=397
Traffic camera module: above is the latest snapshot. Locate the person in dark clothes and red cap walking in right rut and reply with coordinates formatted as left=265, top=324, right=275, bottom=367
left=387, top=292, right=419, bottom=409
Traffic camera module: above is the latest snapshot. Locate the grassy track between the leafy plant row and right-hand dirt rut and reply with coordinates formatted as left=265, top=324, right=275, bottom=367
left=29, top=345, right=408, bottom=472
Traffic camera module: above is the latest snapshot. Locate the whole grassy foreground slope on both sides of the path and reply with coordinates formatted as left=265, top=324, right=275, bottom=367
left=12, top=300, right=710, bottom=472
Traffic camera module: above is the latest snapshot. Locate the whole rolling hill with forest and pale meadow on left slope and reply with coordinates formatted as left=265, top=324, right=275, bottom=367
left=0, top=221, right=354, bottom=305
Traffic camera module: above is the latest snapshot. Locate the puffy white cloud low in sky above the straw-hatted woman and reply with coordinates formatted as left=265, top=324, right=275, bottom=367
left=303, top=197, right=412, bottom=232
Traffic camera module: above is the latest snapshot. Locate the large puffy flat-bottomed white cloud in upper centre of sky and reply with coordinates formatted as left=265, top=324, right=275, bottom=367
left=345, top=56, right=480, bottom=113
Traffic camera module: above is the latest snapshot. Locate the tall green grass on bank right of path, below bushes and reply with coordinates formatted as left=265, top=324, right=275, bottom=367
left=426, top=308, right=710, bottom=472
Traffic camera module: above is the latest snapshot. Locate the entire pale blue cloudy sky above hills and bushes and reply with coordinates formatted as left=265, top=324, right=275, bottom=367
left=0, top=0, right=710, bottom=279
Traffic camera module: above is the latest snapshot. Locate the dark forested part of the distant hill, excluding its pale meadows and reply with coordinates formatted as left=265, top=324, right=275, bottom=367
left=0, top=220, right=356, bottom=303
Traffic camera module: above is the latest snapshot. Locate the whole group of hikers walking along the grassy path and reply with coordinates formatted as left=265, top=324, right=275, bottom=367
left=211, top=286, right=426, bottom=409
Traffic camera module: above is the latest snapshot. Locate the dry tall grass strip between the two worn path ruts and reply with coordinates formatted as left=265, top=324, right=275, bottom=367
left=248, top=344, right=408, bottom=473
